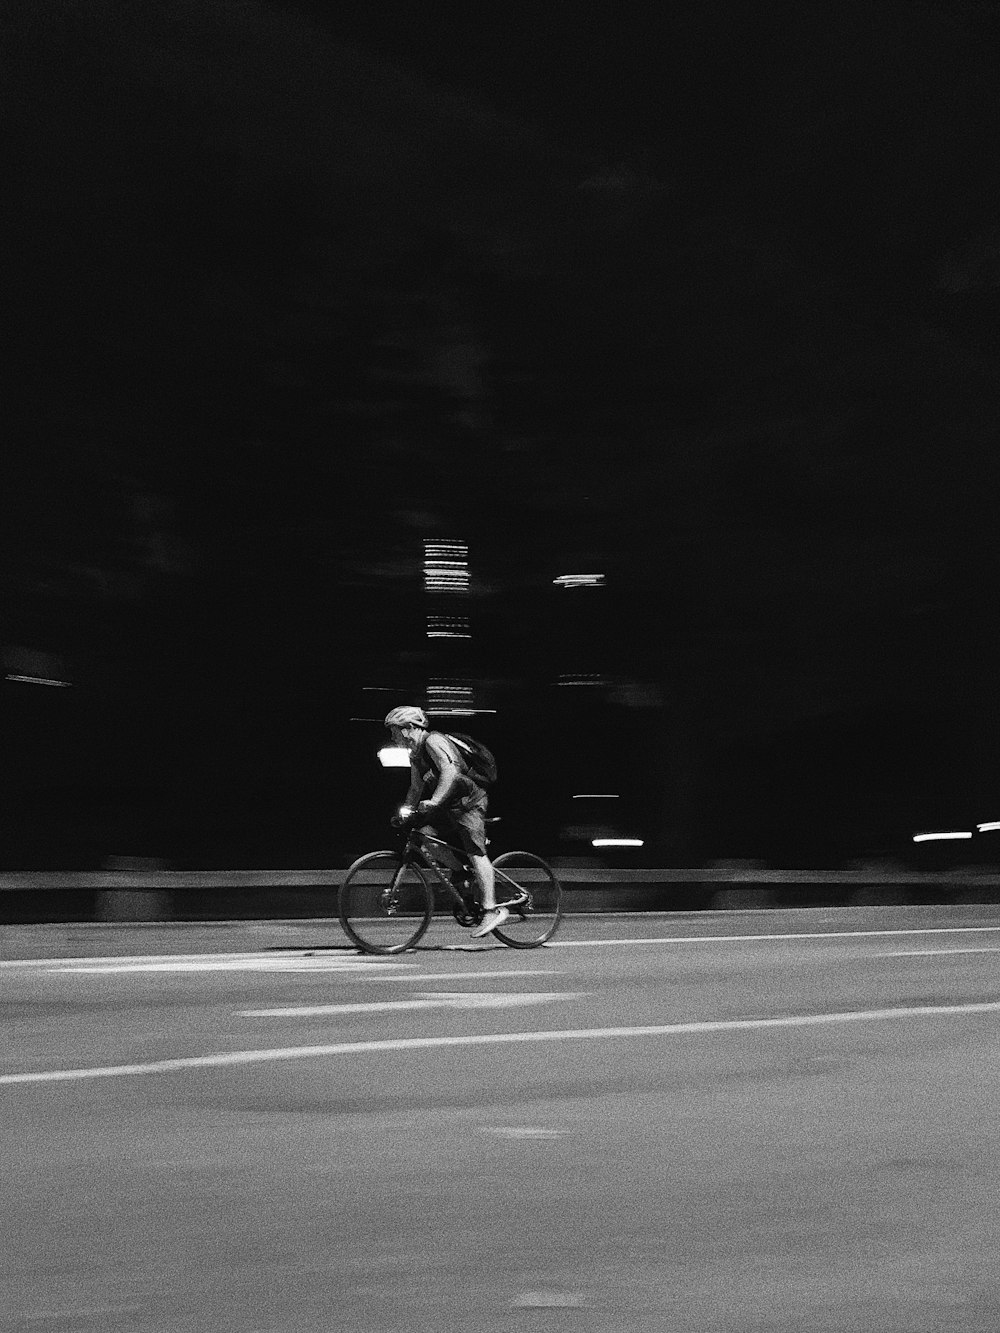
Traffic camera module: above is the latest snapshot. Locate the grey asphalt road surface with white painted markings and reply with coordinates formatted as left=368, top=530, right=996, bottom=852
left=0, top=909, right=1000, bottom=1333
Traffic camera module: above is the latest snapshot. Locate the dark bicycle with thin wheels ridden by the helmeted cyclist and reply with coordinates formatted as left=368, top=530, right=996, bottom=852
left=337, top=818, right=563, bottom=954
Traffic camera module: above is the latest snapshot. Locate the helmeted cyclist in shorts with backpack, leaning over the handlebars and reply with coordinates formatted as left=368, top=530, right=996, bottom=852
left=385, top=706, right=511, bottom=936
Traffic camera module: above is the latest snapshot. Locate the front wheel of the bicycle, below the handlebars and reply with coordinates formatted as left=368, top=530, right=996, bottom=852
left=339, top=852, right=433, bottom=954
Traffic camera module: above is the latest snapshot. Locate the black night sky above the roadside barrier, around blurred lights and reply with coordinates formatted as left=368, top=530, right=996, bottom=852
left=0, top=0, right=1000, bottom=864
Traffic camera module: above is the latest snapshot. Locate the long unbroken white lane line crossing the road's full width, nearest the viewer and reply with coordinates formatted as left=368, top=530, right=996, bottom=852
left=0, top=1001, right=1000, bottom=1084
